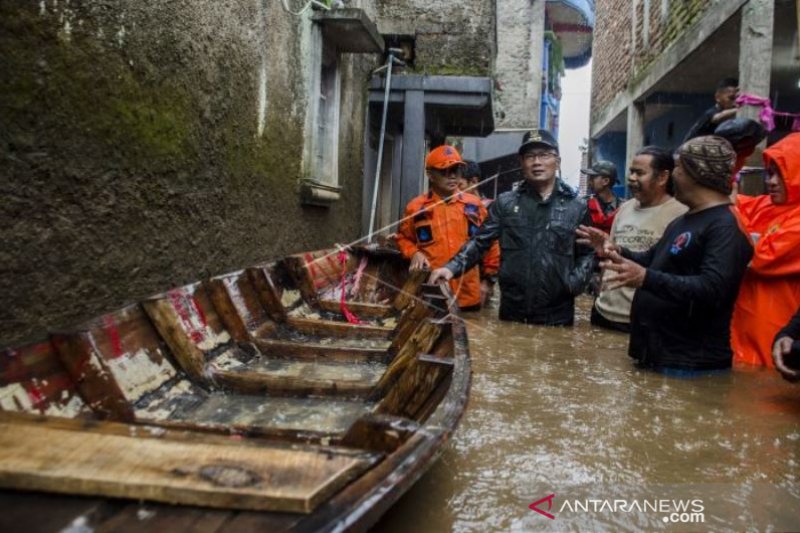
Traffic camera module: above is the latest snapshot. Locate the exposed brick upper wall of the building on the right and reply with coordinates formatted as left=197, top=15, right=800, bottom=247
left=592, top=0, right=722, bottom=117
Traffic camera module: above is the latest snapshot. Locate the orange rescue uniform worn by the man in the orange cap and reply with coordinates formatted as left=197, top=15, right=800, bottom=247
left=396, top=191, right=500, bottom=308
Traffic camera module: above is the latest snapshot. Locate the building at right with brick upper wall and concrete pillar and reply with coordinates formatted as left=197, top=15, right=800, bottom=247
left=591, top=0, right=800, bottom=193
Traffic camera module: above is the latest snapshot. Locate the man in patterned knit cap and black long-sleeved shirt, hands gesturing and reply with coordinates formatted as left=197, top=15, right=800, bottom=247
left=579, top=136, right=753, bottom=374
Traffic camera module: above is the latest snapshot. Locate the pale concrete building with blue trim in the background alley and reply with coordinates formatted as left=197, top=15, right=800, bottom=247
left=463, top=0, right=595, bottom=197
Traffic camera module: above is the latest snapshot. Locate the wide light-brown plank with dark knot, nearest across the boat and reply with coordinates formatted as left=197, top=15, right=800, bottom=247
left=0, top=423, right=377, bottom=513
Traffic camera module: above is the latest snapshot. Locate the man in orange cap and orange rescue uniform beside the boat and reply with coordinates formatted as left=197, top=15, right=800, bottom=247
left=396, top=145, right=499, bottom=311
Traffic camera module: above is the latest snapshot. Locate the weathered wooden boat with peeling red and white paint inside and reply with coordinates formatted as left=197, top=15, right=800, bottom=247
left=0, top=247, right=470, bottom=530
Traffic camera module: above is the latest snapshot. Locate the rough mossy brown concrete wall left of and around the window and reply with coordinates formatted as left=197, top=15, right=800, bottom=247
left=0, top=0, right=378, bottom=346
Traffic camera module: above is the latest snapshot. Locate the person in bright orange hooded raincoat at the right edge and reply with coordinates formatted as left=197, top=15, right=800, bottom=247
left=731, top=133, right=800, bottom=368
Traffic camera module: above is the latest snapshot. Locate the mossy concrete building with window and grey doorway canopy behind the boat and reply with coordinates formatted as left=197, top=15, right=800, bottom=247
left=0, top=0, right=530, bottom=346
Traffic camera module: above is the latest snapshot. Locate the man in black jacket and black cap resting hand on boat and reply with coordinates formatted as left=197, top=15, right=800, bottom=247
left=430, top=130, right=593, bottom=326
